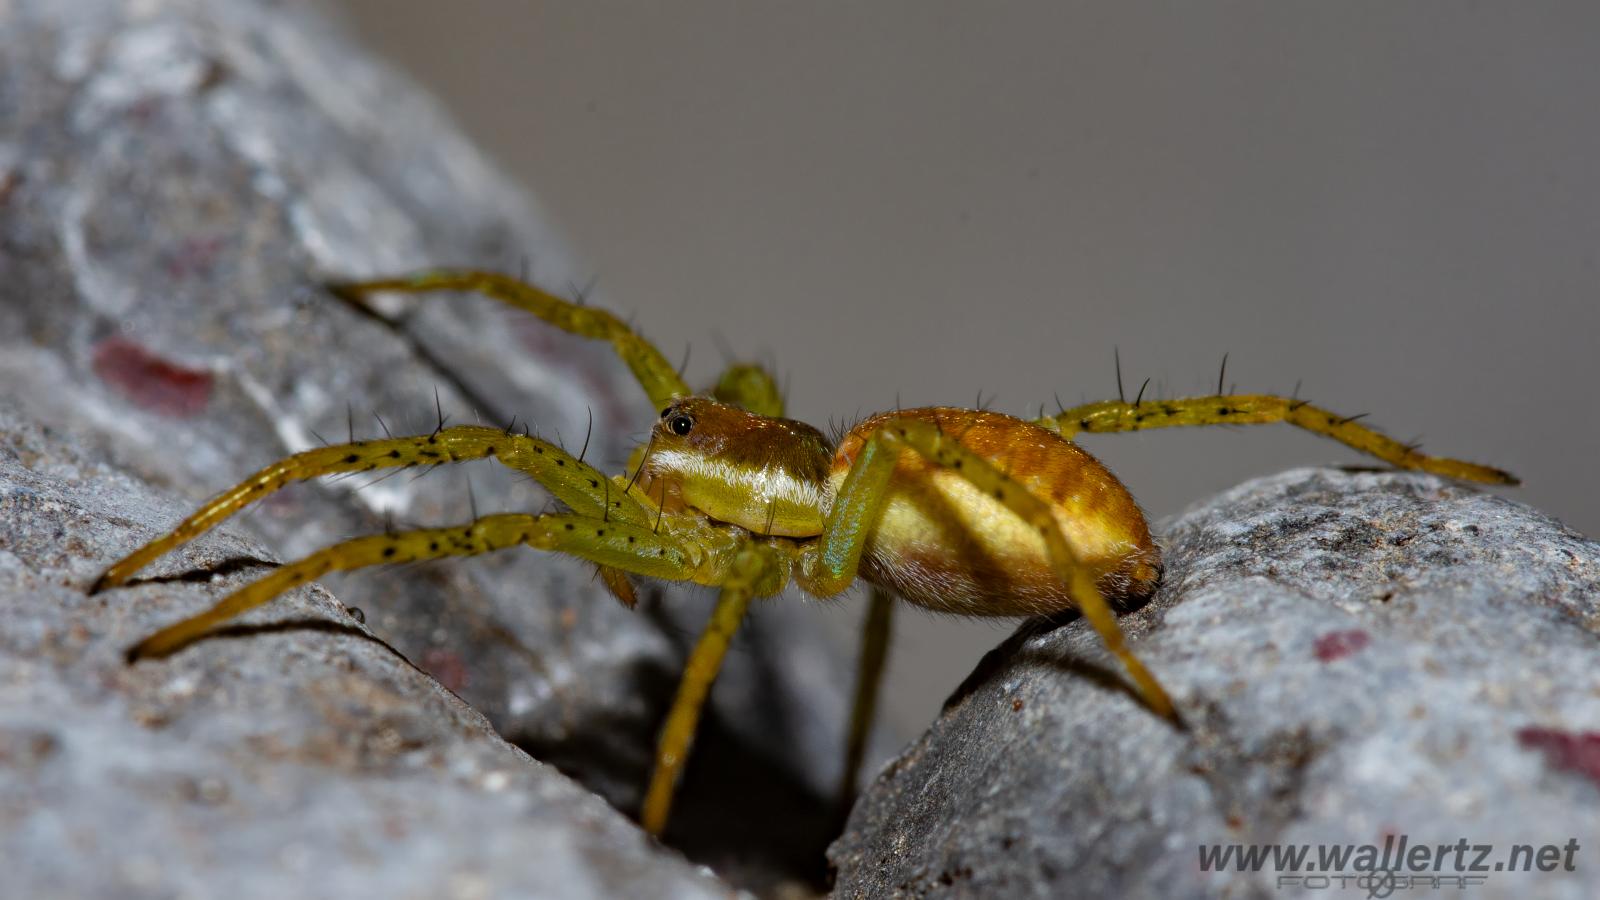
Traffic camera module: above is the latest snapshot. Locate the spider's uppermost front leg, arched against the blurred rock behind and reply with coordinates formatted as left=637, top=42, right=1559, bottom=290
left=328, top=269, right=693, bottom=410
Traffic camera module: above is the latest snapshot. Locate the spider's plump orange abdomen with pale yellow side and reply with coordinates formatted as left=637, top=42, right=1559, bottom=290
left=829, top=407, right=1162, bottom=615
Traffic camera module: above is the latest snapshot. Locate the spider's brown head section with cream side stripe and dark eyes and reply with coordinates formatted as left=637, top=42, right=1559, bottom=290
left=638, top=397, right=834, bottom=536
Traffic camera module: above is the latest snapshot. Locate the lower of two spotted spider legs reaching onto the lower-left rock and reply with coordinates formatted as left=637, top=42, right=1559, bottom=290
left=128, top=512, right=694, bottom=661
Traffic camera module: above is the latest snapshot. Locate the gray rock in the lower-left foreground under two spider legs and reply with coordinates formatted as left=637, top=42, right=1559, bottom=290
left=0, top=405, right=733, bottom=900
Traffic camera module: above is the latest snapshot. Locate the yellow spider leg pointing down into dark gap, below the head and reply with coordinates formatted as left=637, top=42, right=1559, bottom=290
left=638, top=544, right=774, bottom=834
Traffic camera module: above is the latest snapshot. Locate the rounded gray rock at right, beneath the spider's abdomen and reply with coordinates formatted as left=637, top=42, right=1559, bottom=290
left=830, top=469, right=1600, bottom=900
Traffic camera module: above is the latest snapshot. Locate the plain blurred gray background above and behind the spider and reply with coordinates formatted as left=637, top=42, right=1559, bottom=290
left=336, top=0, right=1600, bottom=732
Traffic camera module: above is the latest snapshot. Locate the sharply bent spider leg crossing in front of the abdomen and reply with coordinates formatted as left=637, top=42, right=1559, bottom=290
left=802, top=418, right=1179, bottom=722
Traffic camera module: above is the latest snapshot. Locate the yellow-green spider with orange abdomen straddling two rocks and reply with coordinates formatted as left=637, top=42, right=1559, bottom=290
left=91, top=269, right=1517, bottom=834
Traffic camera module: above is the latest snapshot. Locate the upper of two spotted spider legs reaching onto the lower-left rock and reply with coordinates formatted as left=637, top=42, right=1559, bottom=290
left=90, top=424, right=653, bottom=593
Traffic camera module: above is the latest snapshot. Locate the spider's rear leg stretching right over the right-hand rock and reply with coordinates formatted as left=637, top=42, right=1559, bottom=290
left=1034, top=394, right=1522, bottom=485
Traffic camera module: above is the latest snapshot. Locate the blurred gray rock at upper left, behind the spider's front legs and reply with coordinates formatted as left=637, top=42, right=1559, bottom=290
left=0, top=0, right=876, bottom=881
